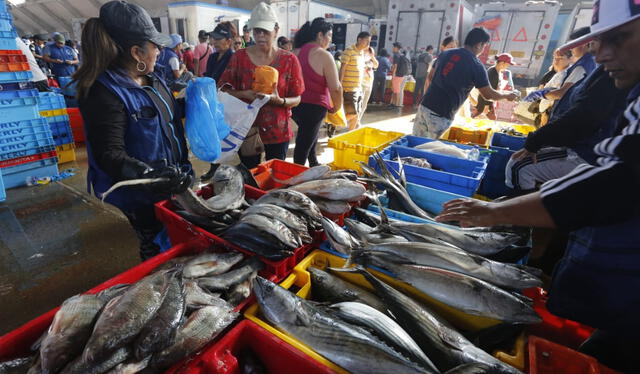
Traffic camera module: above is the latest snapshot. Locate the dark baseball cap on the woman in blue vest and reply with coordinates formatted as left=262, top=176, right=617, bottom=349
left=100, top=0, right=171, bottom=47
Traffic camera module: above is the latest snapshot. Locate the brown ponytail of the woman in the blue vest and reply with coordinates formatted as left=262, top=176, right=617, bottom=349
left=73, top=17, right=121, bottom=100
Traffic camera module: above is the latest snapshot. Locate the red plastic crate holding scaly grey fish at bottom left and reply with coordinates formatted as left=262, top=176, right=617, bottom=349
left=0, top=238, right=276, bottom=369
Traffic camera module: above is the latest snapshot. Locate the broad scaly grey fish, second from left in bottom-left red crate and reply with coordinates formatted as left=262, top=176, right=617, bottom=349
left=82, top=272, right=171, bottom=366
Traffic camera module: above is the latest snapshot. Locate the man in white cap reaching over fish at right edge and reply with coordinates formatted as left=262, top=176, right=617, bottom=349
left=437, top=0, right=640, bottom=373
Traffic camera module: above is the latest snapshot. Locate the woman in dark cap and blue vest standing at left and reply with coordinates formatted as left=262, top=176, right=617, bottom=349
left=74, top=1, right=192, bottom=260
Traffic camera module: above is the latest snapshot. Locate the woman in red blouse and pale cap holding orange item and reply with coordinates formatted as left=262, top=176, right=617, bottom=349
left=218, top=2, right=304, bottom=169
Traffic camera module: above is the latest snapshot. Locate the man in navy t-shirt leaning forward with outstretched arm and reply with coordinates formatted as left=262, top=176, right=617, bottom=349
left=413, top=27, right=518, bottom=139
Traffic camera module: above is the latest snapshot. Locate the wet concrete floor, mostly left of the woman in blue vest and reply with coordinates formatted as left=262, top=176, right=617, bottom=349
left=0, top=103, right=413, bottom=335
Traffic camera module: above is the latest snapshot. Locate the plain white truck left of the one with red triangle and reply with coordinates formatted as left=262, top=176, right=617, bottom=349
left=385, top=0, right=473, bottom=54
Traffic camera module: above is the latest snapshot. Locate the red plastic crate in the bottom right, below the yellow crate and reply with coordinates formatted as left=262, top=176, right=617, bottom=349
left=528, top=336, right=618, bottom=374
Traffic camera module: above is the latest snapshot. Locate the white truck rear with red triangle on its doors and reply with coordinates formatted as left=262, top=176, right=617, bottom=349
left=474, top=1, right=561, bottom=80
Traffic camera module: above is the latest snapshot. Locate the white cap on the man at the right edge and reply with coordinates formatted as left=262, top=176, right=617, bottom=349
left=559, top=0, right=640, bottom=51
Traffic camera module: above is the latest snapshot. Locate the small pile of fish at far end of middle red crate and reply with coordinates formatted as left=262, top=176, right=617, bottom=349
left=272, top=165, right=366, bottom=214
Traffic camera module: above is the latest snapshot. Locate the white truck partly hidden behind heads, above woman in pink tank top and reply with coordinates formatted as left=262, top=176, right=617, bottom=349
left=271, top=0, right=372, bottom=50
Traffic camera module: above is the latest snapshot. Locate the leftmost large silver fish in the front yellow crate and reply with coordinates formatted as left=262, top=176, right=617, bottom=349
left=254, top=277, right=433, bottom=374
